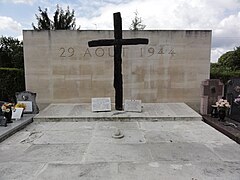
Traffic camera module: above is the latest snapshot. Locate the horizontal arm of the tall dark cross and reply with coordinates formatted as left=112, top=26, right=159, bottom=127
left=88, top=38, right=148, bottom=47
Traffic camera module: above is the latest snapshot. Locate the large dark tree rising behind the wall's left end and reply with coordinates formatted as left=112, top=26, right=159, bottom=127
left=32, top=5, right=79, bottom=30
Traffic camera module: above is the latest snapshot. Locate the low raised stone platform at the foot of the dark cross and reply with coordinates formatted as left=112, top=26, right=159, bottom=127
left=34, top=103, right=202, bottom=122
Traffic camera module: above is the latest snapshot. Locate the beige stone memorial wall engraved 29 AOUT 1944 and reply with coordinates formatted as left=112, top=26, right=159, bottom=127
left=23, top=30, right=211, bottom=107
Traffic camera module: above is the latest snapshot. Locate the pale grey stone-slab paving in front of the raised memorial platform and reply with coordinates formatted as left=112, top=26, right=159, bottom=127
left=0, top=121, right=240, bottom=180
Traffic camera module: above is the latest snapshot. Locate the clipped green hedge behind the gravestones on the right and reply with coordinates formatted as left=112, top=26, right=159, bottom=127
left=210, top=69, right=240, bottom=84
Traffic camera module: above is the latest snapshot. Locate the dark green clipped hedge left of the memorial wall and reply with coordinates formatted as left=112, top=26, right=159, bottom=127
left=0, top=68, right=25, bottom=102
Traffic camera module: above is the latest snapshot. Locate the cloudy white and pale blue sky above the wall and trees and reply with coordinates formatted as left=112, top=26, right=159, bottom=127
left=0, top=0, right=240, bottom=62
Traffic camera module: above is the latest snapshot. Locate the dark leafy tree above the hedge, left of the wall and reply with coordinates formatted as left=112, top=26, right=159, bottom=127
left=0, top=36, right=24, bottom=69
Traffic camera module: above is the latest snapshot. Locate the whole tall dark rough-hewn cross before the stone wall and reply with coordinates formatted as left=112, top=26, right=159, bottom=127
left=88, top=12, right=148, bottom=110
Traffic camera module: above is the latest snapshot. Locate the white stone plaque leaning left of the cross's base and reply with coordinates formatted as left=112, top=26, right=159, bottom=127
left=92, top=97, right=111, bottom=112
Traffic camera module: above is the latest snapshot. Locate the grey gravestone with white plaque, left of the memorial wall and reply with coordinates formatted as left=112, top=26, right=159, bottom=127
left=15, top=91, right=39, bottom=114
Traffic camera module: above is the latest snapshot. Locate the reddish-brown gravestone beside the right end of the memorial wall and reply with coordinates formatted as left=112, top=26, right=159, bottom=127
left=200, top=79, right=224, bottom=115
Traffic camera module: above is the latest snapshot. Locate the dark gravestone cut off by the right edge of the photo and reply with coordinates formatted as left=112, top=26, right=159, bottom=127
left=226, top=78, right=240, bottom=122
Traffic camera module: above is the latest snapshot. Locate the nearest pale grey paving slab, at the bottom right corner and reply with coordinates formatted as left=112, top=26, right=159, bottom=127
left=117, top=161, right=240, bottom=180
